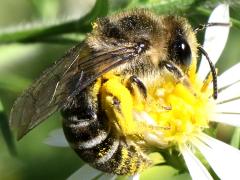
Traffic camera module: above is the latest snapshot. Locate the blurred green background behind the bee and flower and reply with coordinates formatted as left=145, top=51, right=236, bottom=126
left=0, top=0, right=240, bottom=180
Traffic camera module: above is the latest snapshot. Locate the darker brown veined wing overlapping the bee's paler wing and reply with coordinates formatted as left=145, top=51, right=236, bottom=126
left=55, top=46, right=137, bottom=102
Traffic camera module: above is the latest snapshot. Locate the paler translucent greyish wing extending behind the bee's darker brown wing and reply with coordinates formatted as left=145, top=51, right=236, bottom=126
left=10, top=45, right=85, bottom=139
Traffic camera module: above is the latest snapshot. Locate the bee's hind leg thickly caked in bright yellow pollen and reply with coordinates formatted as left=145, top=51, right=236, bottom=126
left=100, top=76, right=137, bottom=135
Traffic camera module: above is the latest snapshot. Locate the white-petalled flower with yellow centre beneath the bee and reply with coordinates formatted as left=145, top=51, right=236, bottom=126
left=47, top=4, right=240, bottom=180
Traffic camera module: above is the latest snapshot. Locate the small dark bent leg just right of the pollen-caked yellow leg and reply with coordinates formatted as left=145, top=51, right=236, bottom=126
left=124, top=75, right=147, bottom=99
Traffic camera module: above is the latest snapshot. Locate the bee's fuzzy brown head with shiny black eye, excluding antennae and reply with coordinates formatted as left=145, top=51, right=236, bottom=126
left=162, top=16, right=198, bottom=71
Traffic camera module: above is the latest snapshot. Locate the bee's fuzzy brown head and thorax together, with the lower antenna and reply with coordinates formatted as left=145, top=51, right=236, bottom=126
left=87, top=9, right=217, bottom=97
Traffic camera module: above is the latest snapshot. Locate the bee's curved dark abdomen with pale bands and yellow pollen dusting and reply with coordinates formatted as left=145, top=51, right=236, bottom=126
left=61, top=87, right=150, bottom=175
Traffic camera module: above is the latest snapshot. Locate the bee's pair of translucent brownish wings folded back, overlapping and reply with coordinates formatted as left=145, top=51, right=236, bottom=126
left=10, top=44, right=138, bottom=139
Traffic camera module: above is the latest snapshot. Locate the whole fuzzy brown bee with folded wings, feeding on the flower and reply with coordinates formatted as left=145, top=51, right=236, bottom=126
left=10, top=9, right=216, bottom=175
